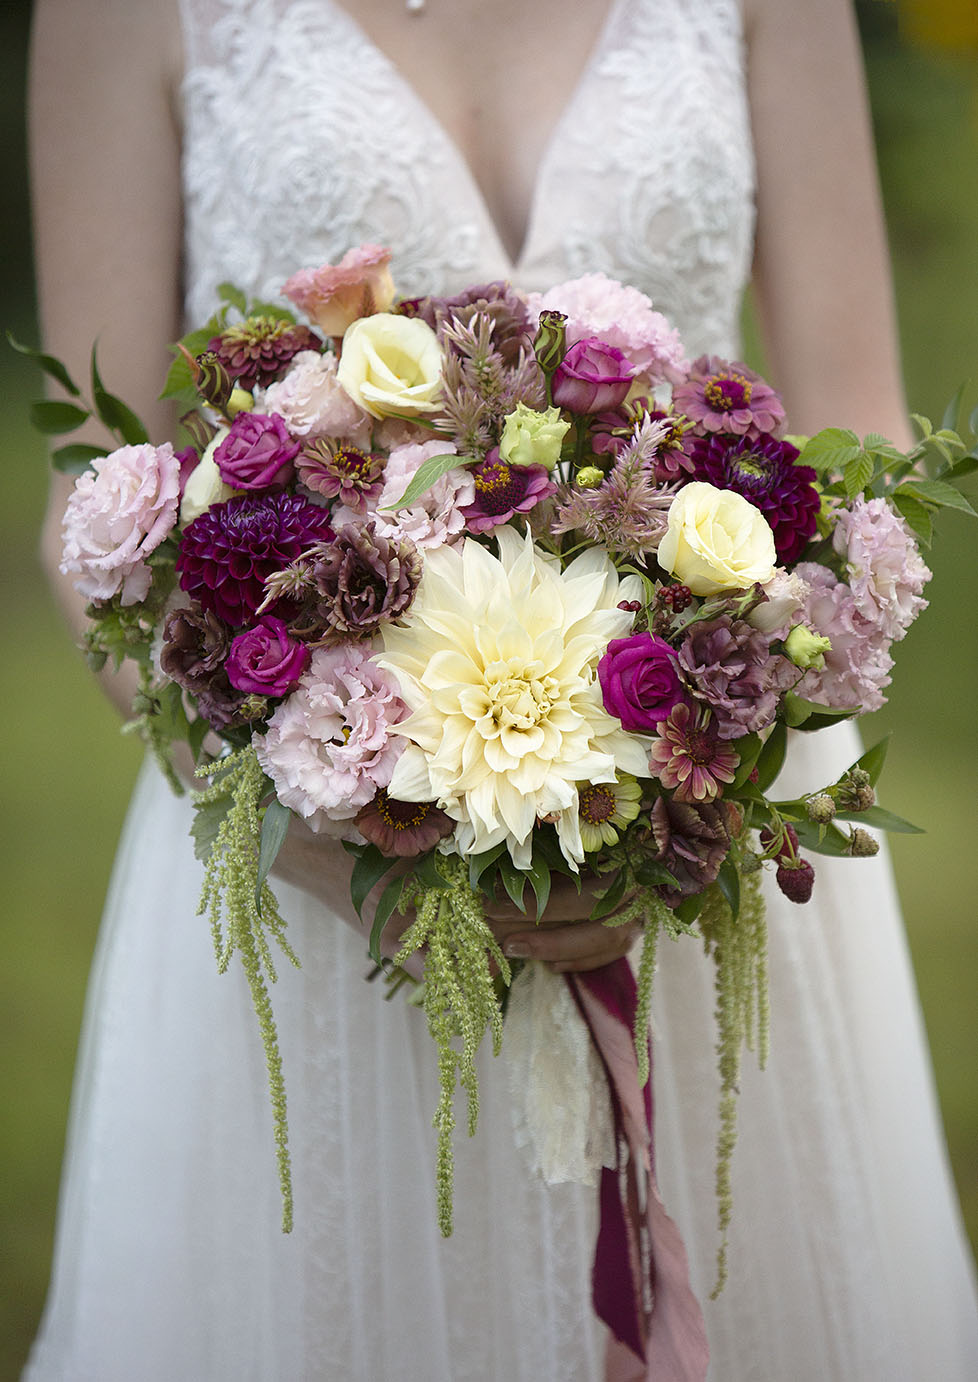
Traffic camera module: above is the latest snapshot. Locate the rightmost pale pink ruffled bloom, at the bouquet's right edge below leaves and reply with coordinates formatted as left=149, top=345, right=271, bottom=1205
left=832, top=498, right=931, bottom=640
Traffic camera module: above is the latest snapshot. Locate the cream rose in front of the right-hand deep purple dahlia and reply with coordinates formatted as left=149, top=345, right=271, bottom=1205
left=658, top=480, right=778, bottom=596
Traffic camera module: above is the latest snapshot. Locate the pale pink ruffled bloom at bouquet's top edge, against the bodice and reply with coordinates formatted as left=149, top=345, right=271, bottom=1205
left=528, top=274, right=689, bottom=384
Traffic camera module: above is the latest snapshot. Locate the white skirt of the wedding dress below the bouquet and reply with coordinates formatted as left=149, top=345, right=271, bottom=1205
left=26, top=728, right=978, bottom=1382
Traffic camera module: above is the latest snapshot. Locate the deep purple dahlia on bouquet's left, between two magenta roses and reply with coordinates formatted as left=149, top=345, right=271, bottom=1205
left=177, top=491, right=333, bottom=629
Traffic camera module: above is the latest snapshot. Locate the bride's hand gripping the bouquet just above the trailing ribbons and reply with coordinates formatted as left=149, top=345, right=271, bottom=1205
left=486, top=875, right=640, bottom=974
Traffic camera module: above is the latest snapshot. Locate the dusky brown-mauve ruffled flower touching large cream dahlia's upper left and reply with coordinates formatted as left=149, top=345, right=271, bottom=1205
left=303, top=522, right=423, bottom=637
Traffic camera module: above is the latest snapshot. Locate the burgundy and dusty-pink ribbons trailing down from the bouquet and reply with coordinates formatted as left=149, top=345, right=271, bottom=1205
left=566, top=959, right=709, bottom=1382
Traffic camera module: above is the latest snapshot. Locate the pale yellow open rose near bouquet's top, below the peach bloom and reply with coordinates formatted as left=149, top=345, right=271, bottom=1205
left=336, top=312, right=442, bottom=417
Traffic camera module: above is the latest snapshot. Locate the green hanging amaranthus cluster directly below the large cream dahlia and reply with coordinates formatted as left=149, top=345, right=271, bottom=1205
left=395, top=857, right=510, bottom=1238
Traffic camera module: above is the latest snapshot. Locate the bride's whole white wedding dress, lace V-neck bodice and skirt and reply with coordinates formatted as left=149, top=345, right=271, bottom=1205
left=26, top=0, right=978, bottom=1382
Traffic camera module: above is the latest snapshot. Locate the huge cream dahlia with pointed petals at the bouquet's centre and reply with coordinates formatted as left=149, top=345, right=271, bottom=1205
left=377, top=528, right=648, bottom=868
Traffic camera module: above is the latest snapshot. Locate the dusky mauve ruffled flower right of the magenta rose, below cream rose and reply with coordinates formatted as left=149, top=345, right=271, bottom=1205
left=678, top=614, right=798, bottom=739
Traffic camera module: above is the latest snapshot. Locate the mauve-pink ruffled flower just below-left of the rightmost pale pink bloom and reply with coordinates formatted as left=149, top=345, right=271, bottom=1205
left=796, top=561, right=894, bottom=710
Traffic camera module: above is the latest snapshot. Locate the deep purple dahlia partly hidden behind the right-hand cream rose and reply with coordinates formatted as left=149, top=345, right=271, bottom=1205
left=695, top=435, right=821, bottom=565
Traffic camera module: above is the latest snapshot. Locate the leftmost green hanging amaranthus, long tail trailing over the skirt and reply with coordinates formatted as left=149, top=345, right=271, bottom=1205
left=195, top=748, right=298, bottom=1233
